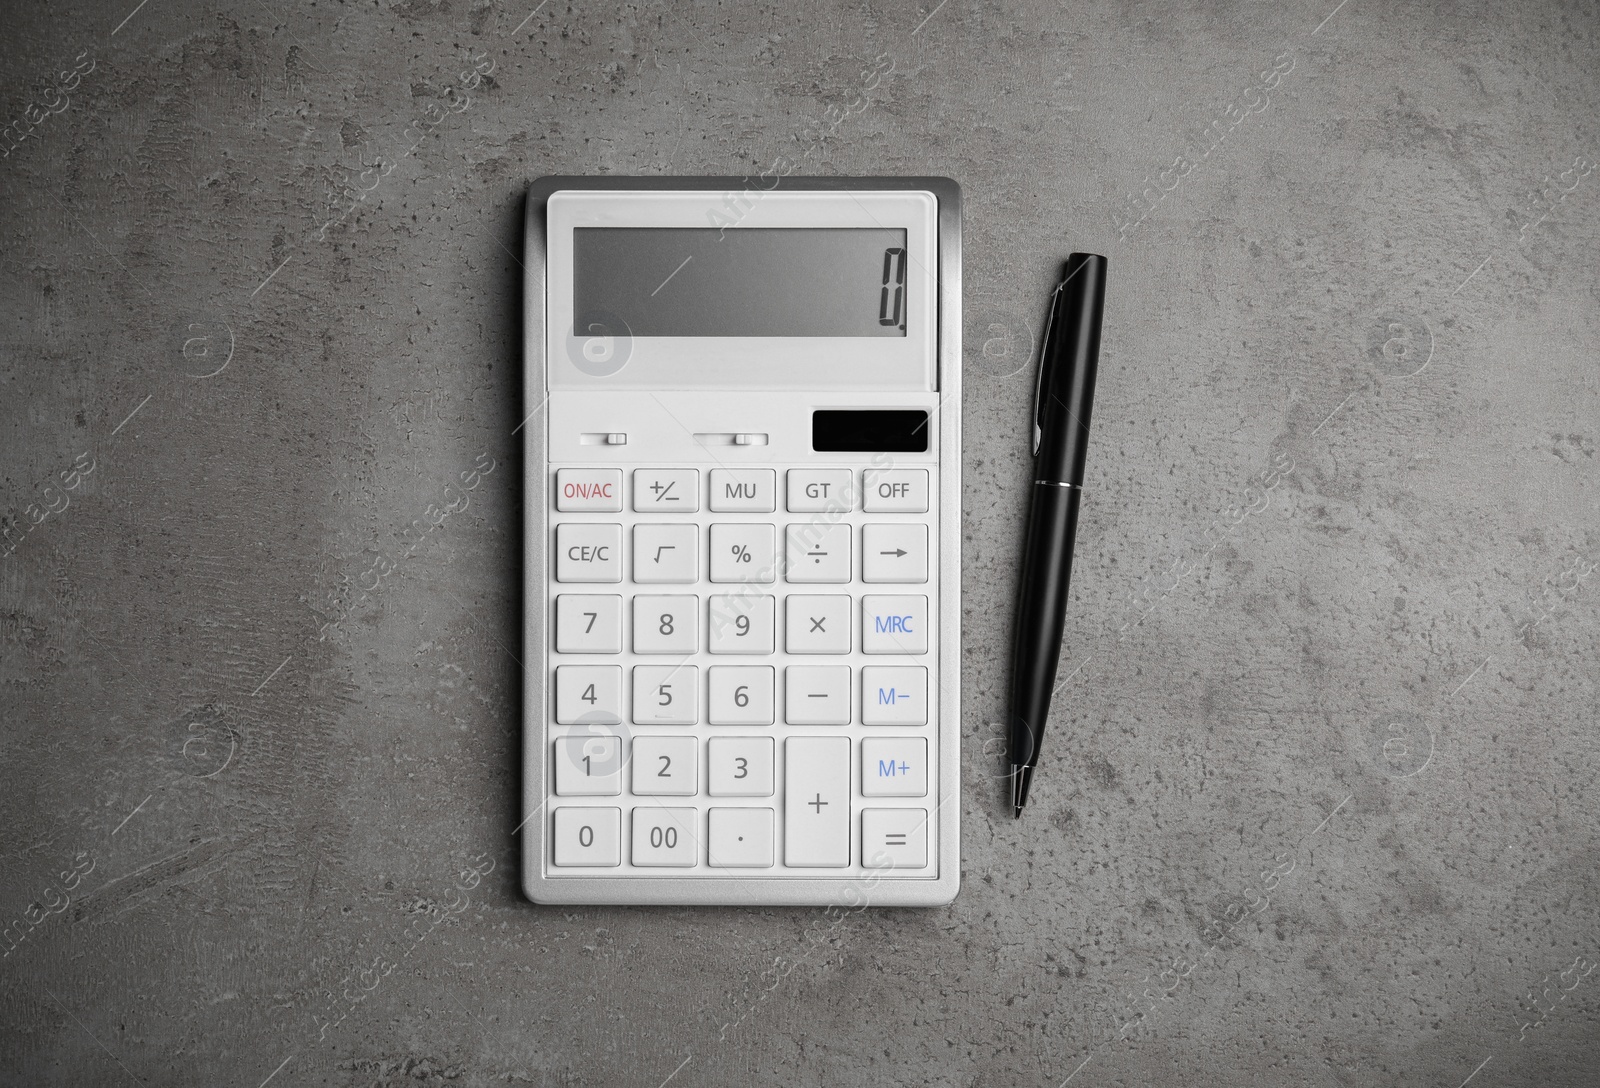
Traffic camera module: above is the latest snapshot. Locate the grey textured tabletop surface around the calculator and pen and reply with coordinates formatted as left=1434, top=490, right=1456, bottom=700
left=0, top=0, right=1600, bottom=1088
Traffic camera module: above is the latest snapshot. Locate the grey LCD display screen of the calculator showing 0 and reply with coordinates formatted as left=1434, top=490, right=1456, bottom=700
left=573, top=227, right=915, bottom=336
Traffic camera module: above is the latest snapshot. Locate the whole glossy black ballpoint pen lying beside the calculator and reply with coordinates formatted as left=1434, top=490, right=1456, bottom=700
left=1011, top=253, right=1106, bottom=816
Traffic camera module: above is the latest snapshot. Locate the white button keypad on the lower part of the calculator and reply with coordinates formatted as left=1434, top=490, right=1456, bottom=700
left=547, top=466, right=938, bottom=875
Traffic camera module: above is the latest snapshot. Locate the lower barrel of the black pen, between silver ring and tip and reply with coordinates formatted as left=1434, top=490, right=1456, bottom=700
left=1010, top=482, right=1080, bottom=766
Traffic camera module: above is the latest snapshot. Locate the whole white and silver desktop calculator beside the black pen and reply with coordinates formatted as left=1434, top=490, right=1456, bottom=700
left=517, top=174, right=962, bottom=907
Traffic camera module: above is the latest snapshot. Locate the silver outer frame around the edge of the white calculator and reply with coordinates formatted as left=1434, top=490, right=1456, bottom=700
left=518, top=174, right=962, bottom=910
